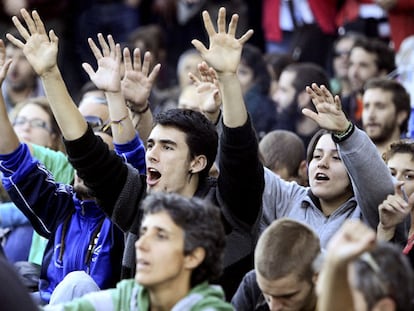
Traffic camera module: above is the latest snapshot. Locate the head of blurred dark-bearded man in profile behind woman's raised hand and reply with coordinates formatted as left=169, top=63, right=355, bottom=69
left=274, top=63, right=329, bottom=147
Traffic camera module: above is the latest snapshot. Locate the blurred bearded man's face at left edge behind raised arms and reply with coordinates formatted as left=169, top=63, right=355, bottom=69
left=1, top=31, right=45, bottom=112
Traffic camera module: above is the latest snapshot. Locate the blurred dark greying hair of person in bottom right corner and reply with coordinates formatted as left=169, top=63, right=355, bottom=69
left=353, top=242, right=414, bottom=311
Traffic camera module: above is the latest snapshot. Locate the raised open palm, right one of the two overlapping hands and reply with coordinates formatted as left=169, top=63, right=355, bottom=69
left=121, top=48, right=161, bottom=111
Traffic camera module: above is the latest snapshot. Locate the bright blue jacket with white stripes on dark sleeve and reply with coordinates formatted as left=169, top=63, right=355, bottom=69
left=0, top=133, right=145, bottom=302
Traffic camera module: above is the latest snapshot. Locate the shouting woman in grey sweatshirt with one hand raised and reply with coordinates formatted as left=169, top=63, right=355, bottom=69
left=260, top=84, right=394, bottom=248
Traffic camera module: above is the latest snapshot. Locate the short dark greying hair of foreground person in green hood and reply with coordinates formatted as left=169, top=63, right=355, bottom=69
left=141, top=192, right=225, bottom=286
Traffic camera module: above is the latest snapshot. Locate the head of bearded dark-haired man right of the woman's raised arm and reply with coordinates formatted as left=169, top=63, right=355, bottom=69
left=362, top=78, right=411, bottom=155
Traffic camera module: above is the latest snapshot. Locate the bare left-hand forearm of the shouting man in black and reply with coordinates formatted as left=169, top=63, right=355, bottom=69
left=41, top=66, right=87, bottom=140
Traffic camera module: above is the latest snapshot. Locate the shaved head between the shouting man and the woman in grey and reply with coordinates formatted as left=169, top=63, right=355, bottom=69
left=259, top=130, right=308, bottom=186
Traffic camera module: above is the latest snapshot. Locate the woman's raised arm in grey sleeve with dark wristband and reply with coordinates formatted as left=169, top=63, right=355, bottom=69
left=303, top=84, right=394, bottom=230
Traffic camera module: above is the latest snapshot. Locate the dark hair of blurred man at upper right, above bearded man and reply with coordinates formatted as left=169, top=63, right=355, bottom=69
left=352, top=37, right=396, bottom=73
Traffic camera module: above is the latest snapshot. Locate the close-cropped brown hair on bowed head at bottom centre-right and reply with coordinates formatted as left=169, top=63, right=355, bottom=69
left=254, top=218, right=320, bottom=282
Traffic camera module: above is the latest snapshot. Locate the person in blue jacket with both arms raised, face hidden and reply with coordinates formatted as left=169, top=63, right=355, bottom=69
left=0, top=33, right=152, bottom=304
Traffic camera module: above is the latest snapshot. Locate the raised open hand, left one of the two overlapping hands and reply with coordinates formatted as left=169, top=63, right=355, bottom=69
left=82, top=33, right=121, bottom=92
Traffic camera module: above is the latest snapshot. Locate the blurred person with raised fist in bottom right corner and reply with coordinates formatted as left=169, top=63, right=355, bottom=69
left=317, top=220, right=414, bottom=311
